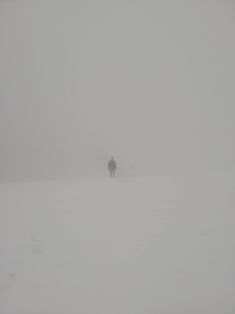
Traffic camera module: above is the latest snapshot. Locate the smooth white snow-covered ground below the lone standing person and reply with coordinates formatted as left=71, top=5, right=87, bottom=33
left=0, top=174, right=235, bottom=314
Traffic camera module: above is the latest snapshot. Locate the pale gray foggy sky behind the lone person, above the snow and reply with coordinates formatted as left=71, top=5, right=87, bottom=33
left=0, top=0, right=235, bottom=180
